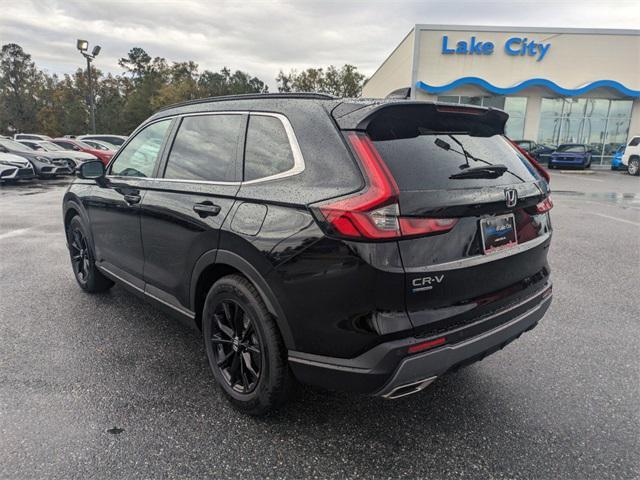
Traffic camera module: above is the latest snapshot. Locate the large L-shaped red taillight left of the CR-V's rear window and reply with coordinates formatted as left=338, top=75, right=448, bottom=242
left=313, top=132, right=457, bottom=240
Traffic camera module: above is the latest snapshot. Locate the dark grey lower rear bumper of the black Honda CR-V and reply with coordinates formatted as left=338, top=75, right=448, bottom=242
left=289, top=284, right=552, bottom=398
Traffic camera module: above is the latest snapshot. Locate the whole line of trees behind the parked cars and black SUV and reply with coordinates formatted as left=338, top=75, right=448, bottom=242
left=0, top=43, right=364, bottom=136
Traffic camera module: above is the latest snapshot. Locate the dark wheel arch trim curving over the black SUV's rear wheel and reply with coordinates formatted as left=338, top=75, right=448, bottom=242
left=190, top=250, right=295, bottom=350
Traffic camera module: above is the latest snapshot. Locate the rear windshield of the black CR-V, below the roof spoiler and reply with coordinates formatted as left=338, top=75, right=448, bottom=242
left=373, top=134, right=538, bottom=191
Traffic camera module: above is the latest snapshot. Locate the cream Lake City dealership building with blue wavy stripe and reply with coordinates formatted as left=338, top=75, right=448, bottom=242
left=363, top=25, right=640, bottom=165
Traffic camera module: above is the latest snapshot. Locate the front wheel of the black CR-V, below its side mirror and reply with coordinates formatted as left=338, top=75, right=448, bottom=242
left=67, top=216, right=113, bottom=293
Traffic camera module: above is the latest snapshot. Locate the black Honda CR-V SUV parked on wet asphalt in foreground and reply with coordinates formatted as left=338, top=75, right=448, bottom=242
left=64, top=94, right=552, bottom=414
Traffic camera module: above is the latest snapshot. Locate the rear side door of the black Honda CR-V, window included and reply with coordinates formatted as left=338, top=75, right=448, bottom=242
left=142, top=113, right=247, bottom=309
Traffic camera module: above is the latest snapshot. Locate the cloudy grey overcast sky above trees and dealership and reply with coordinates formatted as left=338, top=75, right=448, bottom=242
left=0, top=0, right=640, bottom=90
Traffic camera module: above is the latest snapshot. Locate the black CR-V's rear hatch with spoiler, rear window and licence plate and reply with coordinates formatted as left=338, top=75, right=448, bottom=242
left=334, top=102, right=551, bottom=337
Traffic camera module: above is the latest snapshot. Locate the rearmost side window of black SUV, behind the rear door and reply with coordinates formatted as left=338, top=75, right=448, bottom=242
left=244, top=115, right=294, bottom=181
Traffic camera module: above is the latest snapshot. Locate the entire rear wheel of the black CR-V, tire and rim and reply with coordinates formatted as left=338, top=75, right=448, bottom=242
left=202, top=275, right=293, bottom=416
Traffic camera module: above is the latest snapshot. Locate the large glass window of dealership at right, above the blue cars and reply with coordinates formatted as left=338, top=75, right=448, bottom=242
left=538, top=98, right=633, bottom=164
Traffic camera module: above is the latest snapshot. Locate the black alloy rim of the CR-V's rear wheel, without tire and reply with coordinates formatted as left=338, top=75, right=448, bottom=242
left=211, top=299, right=263, bottom=394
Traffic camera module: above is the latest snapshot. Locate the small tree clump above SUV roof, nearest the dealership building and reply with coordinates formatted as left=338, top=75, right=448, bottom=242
left=276, top=64, right=365, bottom=97
